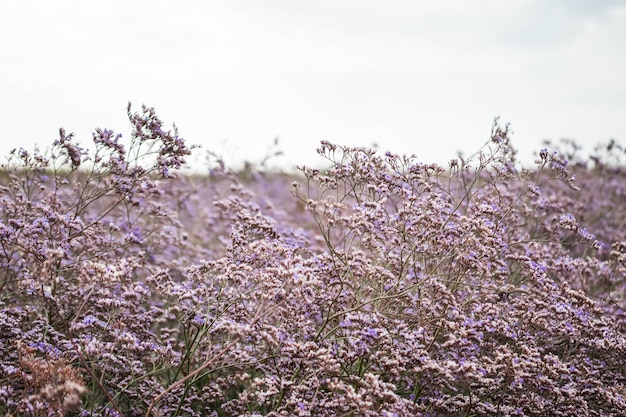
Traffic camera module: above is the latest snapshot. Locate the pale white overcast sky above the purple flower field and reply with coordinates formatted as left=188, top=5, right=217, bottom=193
left=0, top=0, right=626, bottom=166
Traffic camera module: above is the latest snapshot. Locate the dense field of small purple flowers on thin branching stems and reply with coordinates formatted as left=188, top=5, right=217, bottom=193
left=0, top=105, right=626, bottom=417
